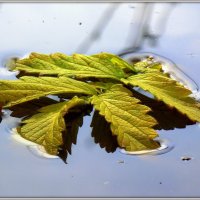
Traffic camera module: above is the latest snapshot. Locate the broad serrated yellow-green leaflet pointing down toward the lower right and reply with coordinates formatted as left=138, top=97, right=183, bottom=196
left=92, top=85, right=159, bottom=151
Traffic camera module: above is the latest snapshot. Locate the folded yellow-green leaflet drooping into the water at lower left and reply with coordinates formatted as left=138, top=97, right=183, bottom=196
left=18, top=97, right=86, bottom=155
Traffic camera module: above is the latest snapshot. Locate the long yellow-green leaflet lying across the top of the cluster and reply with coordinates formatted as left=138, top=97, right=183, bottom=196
left=15, top=53, right=125, bottom=80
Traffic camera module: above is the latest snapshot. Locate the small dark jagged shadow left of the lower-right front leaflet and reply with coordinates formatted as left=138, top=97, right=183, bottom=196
left=90, top=110, right=119, bottom=153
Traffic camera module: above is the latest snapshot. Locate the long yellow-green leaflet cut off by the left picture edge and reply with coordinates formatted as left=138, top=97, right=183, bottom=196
left=0, top=76, right=96, bottom=107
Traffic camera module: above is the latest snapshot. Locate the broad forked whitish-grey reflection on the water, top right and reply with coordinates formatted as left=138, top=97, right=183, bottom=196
left=118, top=3, right=176, bottom=56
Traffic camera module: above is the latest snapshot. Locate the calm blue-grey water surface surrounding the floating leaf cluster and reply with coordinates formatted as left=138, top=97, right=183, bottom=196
left=0, top=3, right=200, bottom=197
